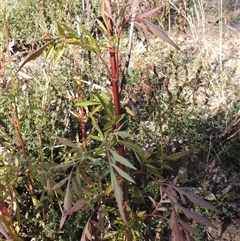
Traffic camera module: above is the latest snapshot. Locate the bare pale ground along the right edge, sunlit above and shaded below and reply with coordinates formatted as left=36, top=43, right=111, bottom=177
left=131, top=0, right=240, bottom=241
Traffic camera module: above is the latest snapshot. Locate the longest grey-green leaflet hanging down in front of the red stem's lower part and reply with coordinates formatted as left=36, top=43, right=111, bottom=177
left=110, top=165, right=127, bottom=224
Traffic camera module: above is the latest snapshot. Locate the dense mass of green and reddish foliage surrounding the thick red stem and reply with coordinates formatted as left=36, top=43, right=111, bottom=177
left=0, top=1, right=239, bottom=240
